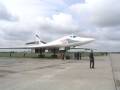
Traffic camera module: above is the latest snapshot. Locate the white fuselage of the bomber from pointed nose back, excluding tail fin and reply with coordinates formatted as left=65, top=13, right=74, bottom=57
left=28, top=35, right=94, bottom=48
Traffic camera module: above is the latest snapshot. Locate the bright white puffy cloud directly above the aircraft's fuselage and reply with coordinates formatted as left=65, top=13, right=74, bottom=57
left=38, top=13, right=78, bottom=34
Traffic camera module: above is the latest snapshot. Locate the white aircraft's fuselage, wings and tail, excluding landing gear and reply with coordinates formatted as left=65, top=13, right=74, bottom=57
left=0, top=35, right=95, bottom=49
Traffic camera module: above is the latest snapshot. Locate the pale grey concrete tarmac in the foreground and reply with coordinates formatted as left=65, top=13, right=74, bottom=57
left=0, top=56, right=116, bottom=90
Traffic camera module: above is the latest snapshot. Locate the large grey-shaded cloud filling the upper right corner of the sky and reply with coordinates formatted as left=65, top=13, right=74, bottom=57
left=69, top=0, right=120, bottom=27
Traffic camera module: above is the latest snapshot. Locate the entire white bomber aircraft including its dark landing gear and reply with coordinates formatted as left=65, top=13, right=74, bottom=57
left=0, top=35, right=95, bottom=58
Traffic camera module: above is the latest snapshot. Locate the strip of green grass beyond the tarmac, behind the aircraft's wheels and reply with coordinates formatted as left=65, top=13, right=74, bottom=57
left=0, top=52, right=106, bottom=59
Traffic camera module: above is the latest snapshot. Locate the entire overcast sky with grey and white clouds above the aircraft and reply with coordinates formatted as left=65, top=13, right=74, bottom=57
left=0, top=0, right=120, bottom=51
